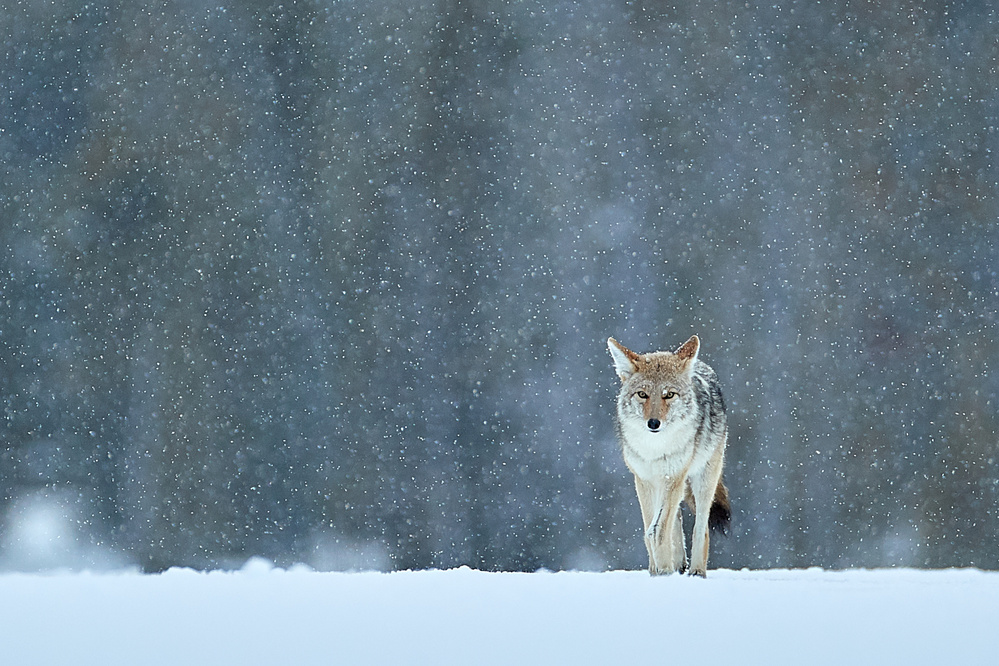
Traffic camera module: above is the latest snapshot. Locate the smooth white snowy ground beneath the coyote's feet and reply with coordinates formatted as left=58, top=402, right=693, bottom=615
left=0, top=562, right=999, bottom=666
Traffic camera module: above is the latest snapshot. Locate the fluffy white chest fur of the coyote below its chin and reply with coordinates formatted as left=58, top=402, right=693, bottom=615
left=621, top=422, right=695, bottom=480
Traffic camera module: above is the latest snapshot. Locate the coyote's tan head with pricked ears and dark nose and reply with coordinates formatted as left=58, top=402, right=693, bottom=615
left=607, top=335, right=700, bottom=433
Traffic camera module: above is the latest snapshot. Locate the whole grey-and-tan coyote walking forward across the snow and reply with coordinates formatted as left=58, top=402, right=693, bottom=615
left=607, top=335, right=731, bottom=577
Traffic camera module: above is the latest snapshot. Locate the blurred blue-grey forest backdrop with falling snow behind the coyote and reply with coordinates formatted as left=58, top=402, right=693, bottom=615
left=0, top=0, right=999, bottom=571
